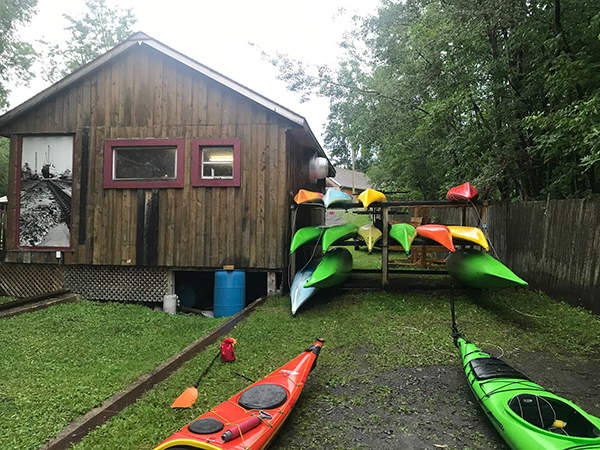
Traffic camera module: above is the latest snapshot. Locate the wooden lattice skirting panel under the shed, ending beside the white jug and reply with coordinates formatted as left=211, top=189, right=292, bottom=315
left=64, top=266, right=174, bottom=302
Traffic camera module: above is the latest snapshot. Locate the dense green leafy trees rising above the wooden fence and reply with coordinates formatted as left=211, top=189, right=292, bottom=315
left=273, top=0, right=600, bottom=199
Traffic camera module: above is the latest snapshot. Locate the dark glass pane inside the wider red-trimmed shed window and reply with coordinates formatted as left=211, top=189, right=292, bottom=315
left=113, top=147, right=177, bottom=180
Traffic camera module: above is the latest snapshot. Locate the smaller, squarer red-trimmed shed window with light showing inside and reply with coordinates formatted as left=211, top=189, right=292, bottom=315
left=192, top=139, right=240, bottom=187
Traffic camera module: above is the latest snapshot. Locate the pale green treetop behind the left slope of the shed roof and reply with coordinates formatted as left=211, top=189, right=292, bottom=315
left=42, top=0, right=137, bottom=83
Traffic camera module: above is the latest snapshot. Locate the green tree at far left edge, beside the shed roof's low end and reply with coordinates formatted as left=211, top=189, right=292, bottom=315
left=0, top=0, right=37, bottom=110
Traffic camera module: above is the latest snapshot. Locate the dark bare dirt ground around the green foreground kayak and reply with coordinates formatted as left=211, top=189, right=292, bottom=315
left=270, top=349, right=600, bottom=450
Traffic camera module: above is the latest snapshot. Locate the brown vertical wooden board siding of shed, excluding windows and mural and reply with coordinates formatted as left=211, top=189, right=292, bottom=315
left=0, top=46, right=318, bottom=270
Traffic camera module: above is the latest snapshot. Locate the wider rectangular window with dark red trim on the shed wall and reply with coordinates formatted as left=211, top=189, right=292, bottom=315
left=104, top=139, right=185, bottom=189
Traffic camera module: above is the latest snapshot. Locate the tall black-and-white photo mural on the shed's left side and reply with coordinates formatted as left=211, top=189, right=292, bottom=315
left=19, top=136, right=73, bottom=248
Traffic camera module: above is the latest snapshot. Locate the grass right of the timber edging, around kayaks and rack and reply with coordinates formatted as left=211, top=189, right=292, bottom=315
left=68, top=290, right=600, bottom=450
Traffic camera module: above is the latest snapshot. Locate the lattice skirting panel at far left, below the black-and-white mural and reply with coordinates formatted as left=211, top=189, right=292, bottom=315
left=0, top=260, right=64, bottom=298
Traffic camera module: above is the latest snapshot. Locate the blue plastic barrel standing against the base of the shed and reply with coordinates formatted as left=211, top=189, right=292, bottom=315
left=213, top=270, right=246, bottom=317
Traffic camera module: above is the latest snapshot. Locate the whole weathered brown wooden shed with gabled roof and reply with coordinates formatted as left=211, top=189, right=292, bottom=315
left=0, top=33, right=335, bottom=302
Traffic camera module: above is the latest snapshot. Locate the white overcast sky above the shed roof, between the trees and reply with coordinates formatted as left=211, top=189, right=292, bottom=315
left=9, top=0, right=380, bottom=143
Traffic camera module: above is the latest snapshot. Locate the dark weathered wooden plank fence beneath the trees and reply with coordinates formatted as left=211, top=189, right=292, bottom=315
left=436, top=199, right=600, bottom=314
